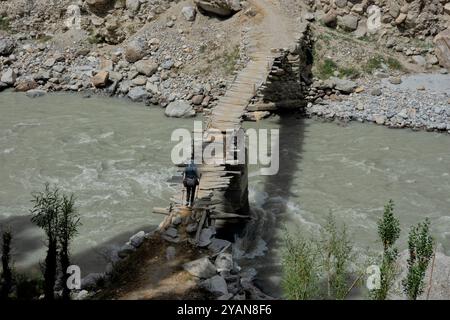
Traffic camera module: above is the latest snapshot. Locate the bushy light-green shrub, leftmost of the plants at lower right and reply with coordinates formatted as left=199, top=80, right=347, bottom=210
left=282, top=235, right=319, bottom=300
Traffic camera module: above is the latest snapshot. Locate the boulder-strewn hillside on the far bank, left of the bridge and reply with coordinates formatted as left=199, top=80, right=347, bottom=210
left=0, top=0, right=252, bottom=116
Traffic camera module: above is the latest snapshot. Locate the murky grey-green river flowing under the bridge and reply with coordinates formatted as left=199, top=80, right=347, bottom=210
left=0, top=92, right=450, bottom=295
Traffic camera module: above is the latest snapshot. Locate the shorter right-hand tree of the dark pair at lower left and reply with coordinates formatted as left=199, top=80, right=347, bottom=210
left=58, top=195, right=80, bottom=300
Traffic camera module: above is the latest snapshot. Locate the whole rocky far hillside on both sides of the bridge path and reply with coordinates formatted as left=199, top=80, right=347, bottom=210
left=0, top=0, right=450, bottom=124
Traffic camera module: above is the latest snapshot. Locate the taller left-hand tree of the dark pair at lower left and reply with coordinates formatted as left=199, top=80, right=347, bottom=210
left=31, top=183, right=61, bottom=300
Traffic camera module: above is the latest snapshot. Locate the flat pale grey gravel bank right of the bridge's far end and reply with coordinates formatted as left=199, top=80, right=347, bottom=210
left=306, top=71, right=450, bottom=133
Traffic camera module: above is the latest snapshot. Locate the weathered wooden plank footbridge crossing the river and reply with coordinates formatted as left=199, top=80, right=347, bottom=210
left=153, top=20, right=306, bottom=243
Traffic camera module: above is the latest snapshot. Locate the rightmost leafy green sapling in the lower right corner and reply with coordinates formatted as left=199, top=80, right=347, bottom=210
left=402, top=218, right=433, bottom=300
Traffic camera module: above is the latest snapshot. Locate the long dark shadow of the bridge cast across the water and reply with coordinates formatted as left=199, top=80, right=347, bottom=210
left=244, top=114, right=306, bottom=297
